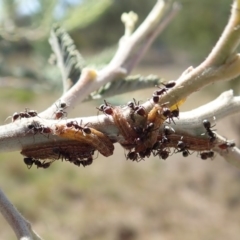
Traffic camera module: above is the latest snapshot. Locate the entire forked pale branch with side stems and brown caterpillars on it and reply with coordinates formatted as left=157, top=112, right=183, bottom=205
left=0, top=0, right=240, bottom=239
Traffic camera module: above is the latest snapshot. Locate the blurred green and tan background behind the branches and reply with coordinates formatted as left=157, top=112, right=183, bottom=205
left=0, top=0, right=240, bottom=240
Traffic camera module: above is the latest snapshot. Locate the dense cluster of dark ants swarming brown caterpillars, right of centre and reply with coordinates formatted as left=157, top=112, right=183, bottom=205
left=94, top=81, right=235, bottom=162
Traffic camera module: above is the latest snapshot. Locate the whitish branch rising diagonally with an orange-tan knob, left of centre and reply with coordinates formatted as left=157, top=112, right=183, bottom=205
left=41, top=0, right=173, bottom=118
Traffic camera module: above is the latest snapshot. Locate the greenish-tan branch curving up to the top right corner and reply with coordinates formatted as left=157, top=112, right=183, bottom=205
left=148, top=1, right=240, bottom=107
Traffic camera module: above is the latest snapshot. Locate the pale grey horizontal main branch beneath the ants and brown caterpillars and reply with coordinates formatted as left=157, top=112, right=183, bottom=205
left=0, top=90, right=240, bottom=152
